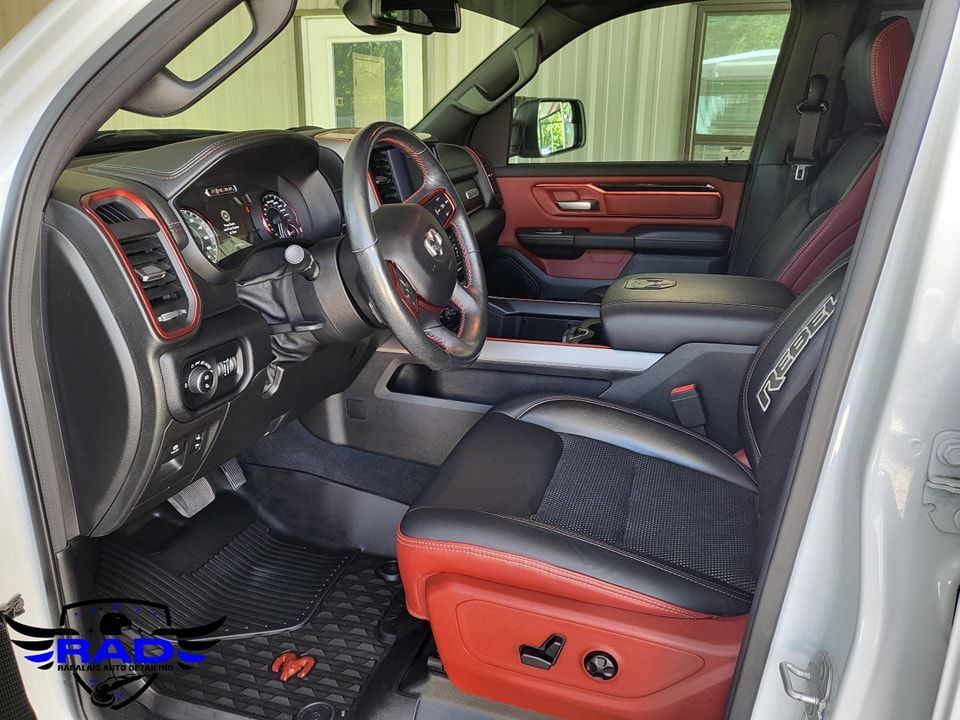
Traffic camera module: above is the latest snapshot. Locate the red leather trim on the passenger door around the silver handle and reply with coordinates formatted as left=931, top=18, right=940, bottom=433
left=497, top=174, right=743, bottom=280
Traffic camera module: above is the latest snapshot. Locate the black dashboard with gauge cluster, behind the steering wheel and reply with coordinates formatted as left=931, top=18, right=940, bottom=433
left=43, top=126, right=504, bottom=536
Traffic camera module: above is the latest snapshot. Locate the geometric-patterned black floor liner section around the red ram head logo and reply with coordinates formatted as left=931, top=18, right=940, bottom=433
left=154, top=555, right=401, bottom=720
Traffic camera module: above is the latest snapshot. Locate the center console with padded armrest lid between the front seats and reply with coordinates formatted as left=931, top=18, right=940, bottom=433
left=303, top=274, right=794, bottom=465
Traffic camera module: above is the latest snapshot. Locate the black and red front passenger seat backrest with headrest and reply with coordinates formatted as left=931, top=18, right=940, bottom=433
left=745, top=17, right=913, bottom=292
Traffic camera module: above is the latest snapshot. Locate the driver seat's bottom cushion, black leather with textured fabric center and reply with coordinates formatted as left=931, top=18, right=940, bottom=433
left=399, top=396, right=757, bottom=616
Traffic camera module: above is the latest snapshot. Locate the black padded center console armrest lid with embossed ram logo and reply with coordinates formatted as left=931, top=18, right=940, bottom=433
left=600, top=274, right=794, bottom=353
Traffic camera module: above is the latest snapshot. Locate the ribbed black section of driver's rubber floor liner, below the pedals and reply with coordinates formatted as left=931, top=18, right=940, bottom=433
left=97, top=521, right=356, bottom=637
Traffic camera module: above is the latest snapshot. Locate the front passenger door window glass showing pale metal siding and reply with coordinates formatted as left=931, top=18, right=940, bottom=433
left=510, top=0, right=790, bottom=163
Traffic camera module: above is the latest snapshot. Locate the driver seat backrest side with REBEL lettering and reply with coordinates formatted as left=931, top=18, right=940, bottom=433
left=740, top=253, right=850, bottom=572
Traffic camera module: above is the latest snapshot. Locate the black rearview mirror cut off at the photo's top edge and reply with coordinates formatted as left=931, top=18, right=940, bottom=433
left=337, top=0, right=460, bottom=35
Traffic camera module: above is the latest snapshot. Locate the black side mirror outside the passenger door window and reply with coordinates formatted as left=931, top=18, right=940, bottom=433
left=510, top=97, right=586, bottom=158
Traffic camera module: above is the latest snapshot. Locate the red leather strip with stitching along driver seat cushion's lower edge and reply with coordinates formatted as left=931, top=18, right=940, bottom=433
left=397, top=530, right=711, bottom=620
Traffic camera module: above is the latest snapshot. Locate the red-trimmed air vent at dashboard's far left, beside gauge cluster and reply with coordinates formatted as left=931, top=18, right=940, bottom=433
left=82, top=190, right=200, bottom=340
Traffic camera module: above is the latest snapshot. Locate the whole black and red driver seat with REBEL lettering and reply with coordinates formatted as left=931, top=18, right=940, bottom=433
left=397, top=259, right=848, bottom=720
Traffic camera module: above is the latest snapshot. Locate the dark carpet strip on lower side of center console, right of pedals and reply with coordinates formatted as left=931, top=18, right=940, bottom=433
left=240, top=422, right=436, bottom=505
